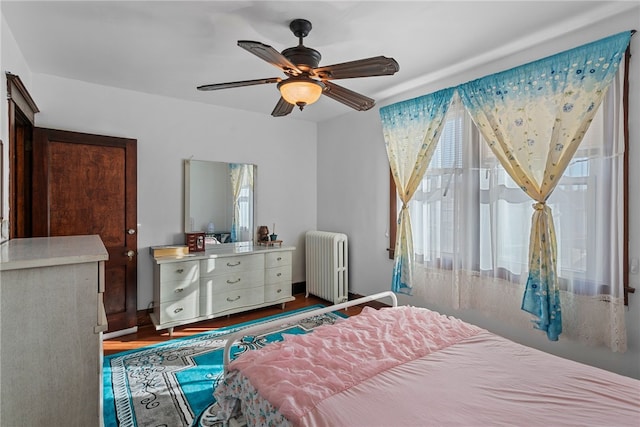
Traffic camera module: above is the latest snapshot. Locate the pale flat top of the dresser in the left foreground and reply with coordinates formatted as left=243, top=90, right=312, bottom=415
left=0, top=235, right=109, bottom=271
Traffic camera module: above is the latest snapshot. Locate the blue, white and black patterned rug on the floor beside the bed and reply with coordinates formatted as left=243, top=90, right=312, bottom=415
left=103, top=305, right=344, bottom=427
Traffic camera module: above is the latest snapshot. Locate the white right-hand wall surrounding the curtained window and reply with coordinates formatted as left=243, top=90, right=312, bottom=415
left=318, top=7, right=640, bottom=378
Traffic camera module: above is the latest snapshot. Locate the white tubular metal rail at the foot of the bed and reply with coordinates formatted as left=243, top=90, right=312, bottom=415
left=223, top=291, right=398, bottom=374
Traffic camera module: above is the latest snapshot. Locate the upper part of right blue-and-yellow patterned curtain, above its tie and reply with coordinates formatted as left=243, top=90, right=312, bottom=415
left=458, top=31, right=631, bottom=202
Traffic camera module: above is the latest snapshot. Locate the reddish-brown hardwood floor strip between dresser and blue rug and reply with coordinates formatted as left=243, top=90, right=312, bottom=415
left=103, top=294, right=382, bottom=355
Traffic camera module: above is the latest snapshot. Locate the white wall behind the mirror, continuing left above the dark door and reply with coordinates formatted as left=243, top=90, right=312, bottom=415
left=0, top=11, right=317, bottom=309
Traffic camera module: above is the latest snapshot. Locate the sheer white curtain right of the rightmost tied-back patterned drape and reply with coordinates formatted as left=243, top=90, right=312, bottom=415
left=549, top=60, right=627, bottom=352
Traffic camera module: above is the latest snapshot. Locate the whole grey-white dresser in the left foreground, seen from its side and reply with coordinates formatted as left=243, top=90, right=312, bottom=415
left=0, top=236, right=108, bottom=427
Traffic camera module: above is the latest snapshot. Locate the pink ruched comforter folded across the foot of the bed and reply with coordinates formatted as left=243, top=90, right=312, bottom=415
left=229, top=306, right=483, bottom=424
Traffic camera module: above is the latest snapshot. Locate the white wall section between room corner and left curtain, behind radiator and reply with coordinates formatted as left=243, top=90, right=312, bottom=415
left=318, top=109, right=392, bottom=295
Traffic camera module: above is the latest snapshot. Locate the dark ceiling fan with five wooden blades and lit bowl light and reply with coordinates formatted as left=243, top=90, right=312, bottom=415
left=197, top=19, right=400, bottom=117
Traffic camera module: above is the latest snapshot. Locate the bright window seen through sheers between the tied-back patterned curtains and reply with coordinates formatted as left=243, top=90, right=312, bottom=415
left=390, top=65, right=628, bottom=302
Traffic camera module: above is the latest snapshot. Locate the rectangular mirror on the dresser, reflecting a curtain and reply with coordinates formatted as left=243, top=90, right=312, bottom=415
left=184, top=159, right=257, bottom=244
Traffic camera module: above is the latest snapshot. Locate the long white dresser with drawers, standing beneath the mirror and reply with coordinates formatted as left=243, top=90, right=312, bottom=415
left=151, top=243, right=295, bottom=334
